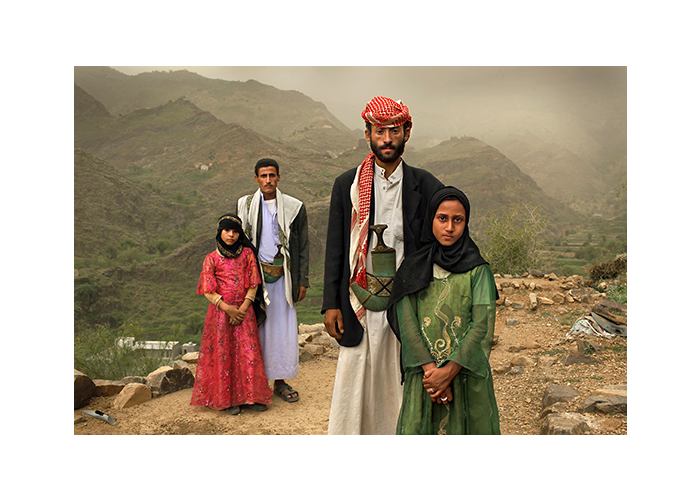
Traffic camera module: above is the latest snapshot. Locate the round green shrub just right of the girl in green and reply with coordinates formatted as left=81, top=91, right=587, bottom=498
left=483, top=205, right=546, bottom=274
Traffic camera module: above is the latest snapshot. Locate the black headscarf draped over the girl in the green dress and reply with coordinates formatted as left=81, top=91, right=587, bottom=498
left=387, top=186, right=488, bottom=336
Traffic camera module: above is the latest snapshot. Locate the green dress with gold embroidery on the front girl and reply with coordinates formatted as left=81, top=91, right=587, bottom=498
left=396, top=264, right=500, bottom=434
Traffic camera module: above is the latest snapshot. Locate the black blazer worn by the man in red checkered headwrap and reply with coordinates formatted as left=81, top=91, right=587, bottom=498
left=321, top=162, right=443, bottom=347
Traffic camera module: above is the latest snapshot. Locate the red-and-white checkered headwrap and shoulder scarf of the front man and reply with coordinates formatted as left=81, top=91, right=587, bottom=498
left=350, top=96, right=411, bottom=320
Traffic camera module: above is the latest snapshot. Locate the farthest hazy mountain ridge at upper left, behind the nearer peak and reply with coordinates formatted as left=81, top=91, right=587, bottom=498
left=75, top=67, right=356, bottom=154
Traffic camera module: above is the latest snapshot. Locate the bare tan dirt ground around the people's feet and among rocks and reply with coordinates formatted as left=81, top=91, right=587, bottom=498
left=74, top=278, right=627, bottom=434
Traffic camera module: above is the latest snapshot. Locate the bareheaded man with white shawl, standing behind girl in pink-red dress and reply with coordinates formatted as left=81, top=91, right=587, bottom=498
left=236, top=158, right=309, bottom=403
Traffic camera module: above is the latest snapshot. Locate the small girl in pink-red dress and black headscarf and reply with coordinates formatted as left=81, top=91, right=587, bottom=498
left=190, top=214, right=272, bottom=415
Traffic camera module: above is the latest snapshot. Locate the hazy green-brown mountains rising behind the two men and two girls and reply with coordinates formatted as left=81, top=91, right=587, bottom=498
left=74, top=68, right=628, bottom=338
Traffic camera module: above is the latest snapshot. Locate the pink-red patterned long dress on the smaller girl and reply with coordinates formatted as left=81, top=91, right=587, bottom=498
left=190, top=247, right=272, bottom=410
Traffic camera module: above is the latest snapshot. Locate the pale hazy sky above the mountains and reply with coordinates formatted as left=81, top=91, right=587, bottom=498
left=115, top=66, right=627, bottom=151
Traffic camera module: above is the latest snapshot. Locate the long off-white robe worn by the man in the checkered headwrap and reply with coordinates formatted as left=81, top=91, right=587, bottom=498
left=328, top=162, right=404, bottom=434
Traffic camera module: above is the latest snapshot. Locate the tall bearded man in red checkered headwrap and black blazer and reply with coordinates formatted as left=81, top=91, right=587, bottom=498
left=322, top=96, right=442, bottom=434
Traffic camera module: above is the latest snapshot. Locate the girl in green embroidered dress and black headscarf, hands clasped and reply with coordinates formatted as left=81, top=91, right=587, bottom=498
left=387, top=186, right=500, bottom=434
